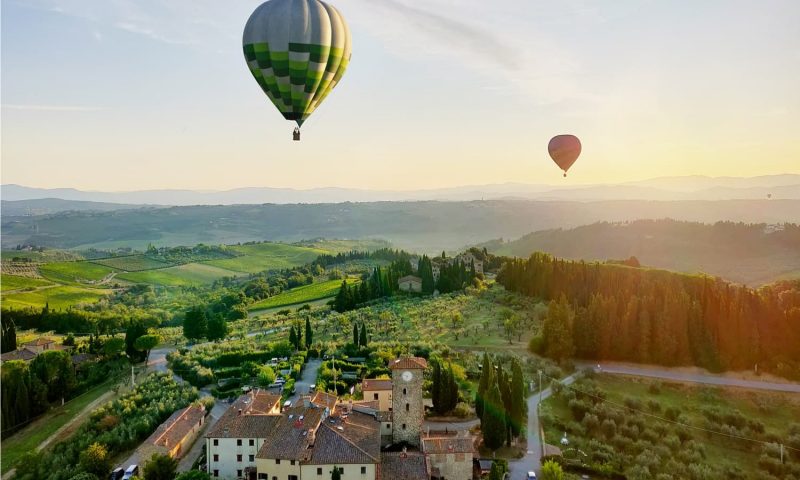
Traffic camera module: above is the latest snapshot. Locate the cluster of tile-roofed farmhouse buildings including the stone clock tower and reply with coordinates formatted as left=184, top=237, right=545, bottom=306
left=206, top=357, right=472, bottom=480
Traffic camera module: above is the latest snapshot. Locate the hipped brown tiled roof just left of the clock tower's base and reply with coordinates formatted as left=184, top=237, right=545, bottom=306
left=309, top=409, right=381, bottom=465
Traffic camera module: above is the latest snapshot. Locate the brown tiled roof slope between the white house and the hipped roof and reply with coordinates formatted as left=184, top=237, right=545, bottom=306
left=257, top=406, right=325, bottom=462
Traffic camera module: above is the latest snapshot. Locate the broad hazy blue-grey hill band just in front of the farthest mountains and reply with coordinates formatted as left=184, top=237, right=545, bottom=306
left=1, top=199, right=800, bottom=253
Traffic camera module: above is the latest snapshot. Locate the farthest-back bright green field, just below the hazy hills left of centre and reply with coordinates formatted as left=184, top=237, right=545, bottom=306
left=205, top=243, right=328, bottom=273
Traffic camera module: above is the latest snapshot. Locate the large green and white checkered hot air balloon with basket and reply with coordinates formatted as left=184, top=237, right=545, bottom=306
left=242, top=0, right=351, bottom=140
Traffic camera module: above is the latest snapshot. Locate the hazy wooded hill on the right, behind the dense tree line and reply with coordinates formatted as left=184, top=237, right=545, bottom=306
left=478, top=219, right=800, bottom=286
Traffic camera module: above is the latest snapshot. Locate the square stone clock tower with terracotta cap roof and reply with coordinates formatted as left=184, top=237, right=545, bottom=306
left=389, top=357, right=428, bottom=447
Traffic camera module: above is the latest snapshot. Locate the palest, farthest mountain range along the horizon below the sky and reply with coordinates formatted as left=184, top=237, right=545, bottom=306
left=0, top=174, right=800, bottom=207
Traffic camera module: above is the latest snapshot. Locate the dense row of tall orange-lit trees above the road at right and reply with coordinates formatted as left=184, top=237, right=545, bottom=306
left=497, top=253, right=800, bottom=378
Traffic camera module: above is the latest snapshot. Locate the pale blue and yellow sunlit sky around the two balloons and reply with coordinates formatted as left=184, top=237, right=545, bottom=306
left=0, top=0, right=800, bottom=191
